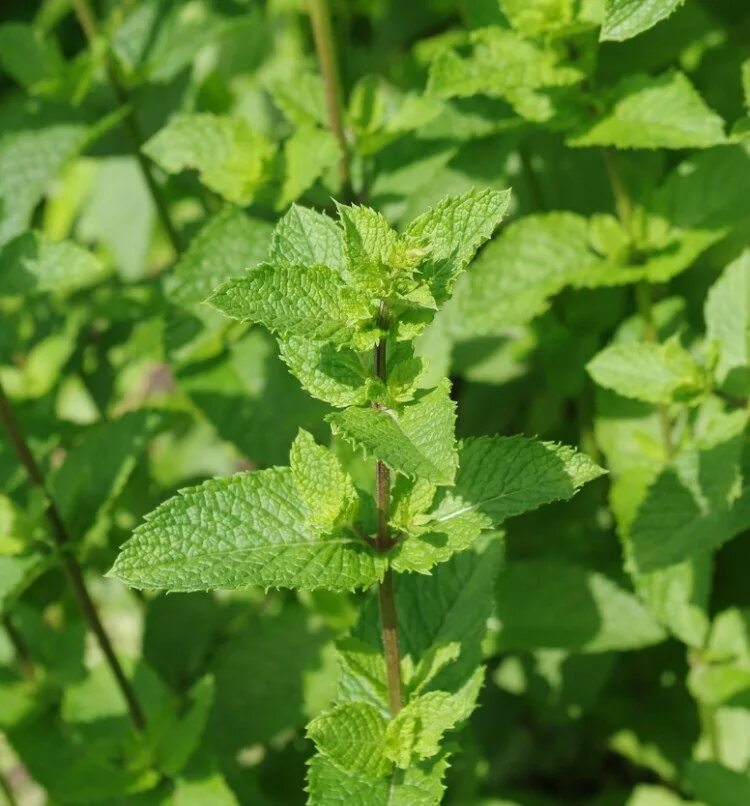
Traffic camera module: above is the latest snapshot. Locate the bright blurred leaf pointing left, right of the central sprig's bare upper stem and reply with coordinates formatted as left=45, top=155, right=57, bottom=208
left=586, top=339, right=706, bottom=404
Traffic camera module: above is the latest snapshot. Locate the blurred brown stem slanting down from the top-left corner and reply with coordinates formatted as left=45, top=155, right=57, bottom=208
left=72, top=0, right=183, bottom=254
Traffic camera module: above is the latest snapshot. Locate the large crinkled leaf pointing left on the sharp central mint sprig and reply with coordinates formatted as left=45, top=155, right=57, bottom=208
left=110, top=468, right=385, bottom=591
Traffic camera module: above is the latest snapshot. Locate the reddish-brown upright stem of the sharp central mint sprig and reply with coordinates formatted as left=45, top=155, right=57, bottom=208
left=373, top=302, right=404, bottom=716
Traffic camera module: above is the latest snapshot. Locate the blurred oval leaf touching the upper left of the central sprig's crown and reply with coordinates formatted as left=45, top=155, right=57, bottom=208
left=166, top=207, right=271, bottom=308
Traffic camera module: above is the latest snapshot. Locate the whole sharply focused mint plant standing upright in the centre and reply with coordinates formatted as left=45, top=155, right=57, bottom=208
left=113, top=190, right=602, bottom=804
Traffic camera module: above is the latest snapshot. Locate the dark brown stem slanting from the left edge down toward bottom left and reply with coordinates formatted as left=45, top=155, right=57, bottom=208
left=0, top=383, right=146, bottom=731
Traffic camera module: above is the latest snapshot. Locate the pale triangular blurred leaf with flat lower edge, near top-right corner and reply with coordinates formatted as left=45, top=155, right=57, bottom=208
left=568, top=72, right=726, bottom=148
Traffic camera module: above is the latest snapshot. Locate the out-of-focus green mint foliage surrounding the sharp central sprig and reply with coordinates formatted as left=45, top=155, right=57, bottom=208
left=0, top=0, right=750, bottom=806
